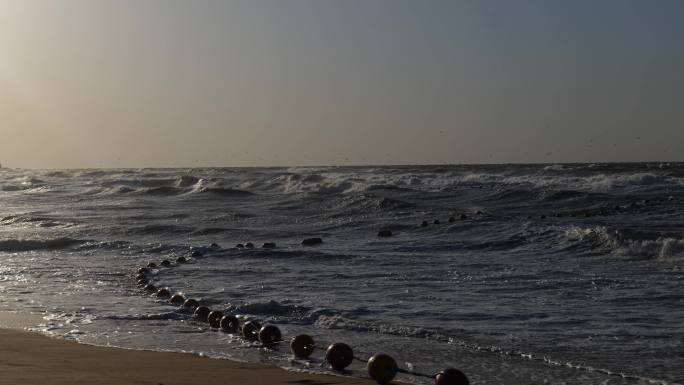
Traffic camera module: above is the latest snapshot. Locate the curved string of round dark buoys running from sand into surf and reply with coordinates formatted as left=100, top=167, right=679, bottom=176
left=135, top=246, right=469, bottom=385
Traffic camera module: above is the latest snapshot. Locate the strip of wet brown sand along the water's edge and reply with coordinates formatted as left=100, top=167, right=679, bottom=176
left=0, top=313, right=398, bottom=385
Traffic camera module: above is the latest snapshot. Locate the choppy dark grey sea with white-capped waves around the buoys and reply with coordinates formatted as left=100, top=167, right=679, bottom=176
left=0, top=164, right=684, bottom=384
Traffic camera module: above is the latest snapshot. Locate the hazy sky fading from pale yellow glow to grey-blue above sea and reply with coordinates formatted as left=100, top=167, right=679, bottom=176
left=0, top=0, right=684, bottom=168
